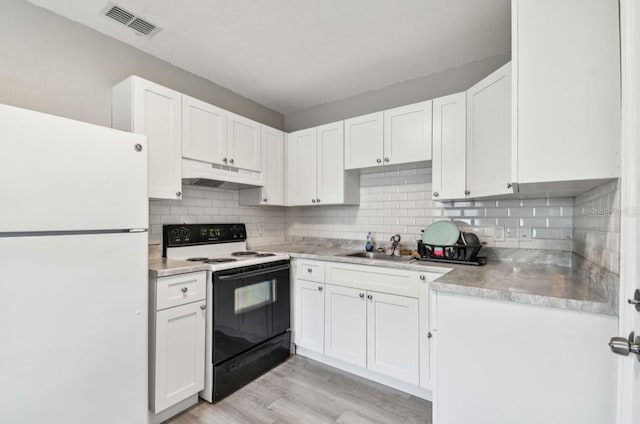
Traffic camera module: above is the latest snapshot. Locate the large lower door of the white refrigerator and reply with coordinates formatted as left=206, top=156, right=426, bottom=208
left=0, top=233, right=148, bottom=424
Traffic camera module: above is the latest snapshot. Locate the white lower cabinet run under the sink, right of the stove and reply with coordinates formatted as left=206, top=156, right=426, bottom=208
left=294, top=259, right=441, bottom=399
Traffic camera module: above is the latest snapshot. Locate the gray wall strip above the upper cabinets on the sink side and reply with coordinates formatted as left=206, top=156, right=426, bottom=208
left=285, top=53, right=511, bottom=131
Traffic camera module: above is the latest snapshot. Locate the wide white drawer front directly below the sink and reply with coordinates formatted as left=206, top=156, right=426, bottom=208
left=326, top=262, right=428, bottom=298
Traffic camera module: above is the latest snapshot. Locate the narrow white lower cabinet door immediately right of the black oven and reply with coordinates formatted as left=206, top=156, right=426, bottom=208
left=294, top=280, right=324, bottom=353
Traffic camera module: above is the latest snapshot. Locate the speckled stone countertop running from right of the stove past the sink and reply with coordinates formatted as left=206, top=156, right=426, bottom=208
left=251, top=239, right=618, bottom=315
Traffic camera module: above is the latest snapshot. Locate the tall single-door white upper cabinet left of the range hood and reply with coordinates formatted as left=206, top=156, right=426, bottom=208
left=112, top=76, right=182, bottom=199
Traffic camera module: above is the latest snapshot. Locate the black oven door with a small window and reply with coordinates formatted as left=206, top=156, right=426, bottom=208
left=212, top=261, right=290, bottom=365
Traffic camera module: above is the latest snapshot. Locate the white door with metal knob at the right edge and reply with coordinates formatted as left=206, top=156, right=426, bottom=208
left=617, top=0, right=640, bottom=424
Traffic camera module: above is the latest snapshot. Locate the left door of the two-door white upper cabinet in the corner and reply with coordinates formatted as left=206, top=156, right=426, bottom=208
left=287, top=128, right=317, bottom=206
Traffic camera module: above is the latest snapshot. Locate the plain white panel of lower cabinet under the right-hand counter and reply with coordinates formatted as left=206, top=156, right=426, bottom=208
left=431, top=292, right=618, bottom=424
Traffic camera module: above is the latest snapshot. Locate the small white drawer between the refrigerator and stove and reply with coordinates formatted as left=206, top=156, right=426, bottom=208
left=156, top=271, right=207, bottom=311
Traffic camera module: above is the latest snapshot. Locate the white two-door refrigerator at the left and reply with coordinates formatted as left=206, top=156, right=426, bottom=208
left=0, top=105, right=148, bottom=424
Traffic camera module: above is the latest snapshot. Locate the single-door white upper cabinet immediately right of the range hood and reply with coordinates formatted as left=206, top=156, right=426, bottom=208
left=240, top=125, right=285, bottom=206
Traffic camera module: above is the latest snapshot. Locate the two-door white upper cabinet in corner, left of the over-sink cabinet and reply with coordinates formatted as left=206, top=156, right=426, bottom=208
left=286, top=121, right=360, bottom=206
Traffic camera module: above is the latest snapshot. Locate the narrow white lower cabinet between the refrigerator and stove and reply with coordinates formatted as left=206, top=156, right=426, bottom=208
left=149, top=272, right=207, bottom=414
